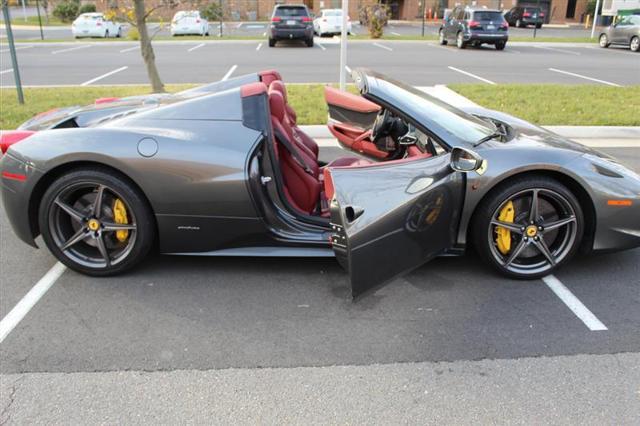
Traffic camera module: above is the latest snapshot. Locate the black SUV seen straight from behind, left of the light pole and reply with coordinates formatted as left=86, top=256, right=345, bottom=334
left=269, top=4, right=313, bottom=47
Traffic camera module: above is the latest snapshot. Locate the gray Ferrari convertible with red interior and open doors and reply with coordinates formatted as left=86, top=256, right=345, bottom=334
left=0, top=69, right=640, bottom=297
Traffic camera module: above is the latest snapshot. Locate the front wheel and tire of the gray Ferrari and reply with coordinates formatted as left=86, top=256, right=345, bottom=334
left=471, top=176, right=584, bottom=279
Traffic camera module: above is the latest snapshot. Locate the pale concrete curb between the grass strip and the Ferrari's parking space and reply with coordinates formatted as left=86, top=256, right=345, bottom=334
left=300, top=125, right=640, bottom=140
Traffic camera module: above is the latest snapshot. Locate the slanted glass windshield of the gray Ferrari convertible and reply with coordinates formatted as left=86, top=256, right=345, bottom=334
left=364, top=74, right=496, bottom=143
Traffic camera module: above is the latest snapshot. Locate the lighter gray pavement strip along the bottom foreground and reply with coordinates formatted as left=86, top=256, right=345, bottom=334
left=0, top=353, right=640, bottom=425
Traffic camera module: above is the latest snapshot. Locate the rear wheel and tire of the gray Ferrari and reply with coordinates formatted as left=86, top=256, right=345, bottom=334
left=38, top=168, right=156, bottom=276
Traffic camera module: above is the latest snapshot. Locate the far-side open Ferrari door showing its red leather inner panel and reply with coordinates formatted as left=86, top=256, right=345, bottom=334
left=324, top=86, right=389, bottom=160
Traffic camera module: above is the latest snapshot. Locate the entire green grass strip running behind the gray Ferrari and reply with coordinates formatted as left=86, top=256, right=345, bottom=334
left=0, top=84, right=640, bottom=129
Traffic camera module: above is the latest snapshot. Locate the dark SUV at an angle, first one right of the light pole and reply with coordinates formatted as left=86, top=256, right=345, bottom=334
left=438, top=6, right=509, bottom=50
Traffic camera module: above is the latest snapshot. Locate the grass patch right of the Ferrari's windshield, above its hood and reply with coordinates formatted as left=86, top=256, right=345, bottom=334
left=448, top=84, right=640, bottom=126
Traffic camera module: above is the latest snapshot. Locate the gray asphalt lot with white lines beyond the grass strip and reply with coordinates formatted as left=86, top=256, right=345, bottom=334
left=0, top=38, right=640, bottom=87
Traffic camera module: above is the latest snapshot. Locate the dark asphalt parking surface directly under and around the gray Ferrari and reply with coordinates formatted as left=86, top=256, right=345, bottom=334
left=0, top=147, right=640, bottom=373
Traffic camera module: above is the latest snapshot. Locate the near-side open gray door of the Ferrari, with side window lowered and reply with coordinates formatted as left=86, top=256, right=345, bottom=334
left=325, top=154, right=466, bottom=298
